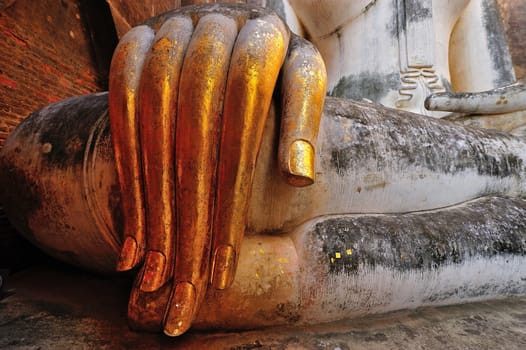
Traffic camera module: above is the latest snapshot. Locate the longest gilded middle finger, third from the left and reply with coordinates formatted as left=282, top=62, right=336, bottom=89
left=164, top=14, right=237, bottom=336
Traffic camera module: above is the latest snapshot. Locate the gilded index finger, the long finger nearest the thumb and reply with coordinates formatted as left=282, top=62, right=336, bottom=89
left=211, top=15, right=289, bottom=289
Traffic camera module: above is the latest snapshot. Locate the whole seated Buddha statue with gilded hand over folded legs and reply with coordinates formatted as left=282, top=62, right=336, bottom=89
left=1, top=0, right=526, bottom=336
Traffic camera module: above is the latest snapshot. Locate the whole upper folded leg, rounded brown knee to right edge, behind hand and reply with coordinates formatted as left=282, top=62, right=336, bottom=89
left=1, top=94, right=526, bottom=271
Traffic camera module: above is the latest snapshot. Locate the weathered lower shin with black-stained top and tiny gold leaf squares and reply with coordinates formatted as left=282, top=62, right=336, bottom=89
left=286, top=197, right=526, bottom=323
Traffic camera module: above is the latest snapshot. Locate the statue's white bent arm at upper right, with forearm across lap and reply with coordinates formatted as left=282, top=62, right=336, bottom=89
left=425, top=1, right=526, bottom=115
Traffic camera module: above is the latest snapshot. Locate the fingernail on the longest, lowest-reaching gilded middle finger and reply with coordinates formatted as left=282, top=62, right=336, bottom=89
left=164, top=282, right=195, bottom=337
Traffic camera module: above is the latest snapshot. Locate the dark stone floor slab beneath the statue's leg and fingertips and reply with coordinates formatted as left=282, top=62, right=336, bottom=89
left=0, top=262, right=526, bottom=350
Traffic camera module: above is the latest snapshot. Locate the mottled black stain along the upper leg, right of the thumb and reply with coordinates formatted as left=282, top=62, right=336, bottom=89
left=326, top=97, right=525, bottom=179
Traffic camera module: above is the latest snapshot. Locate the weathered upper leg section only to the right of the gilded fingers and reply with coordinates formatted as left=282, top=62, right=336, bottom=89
left=249, top=98, right=526, bottom=232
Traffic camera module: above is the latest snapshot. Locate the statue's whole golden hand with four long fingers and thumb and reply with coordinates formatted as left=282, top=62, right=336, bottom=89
left=109, top=5, right=326, bottom=336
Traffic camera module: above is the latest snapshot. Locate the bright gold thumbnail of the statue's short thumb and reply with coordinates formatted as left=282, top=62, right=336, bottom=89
left=287, top=140, right=314, bottom=187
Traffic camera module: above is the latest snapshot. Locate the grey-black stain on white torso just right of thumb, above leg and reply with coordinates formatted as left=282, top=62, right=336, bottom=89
left=329, top=72, right=400, bottom=102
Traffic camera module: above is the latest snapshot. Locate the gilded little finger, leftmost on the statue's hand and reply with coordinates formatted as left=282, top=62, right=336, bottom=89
left=109, top=26, right=154, bottom=271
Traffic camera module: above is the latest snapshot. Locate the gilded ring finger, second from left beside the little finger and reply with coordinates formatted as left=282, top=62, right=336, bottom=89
left=139, top=16, right=193, bottom=292
